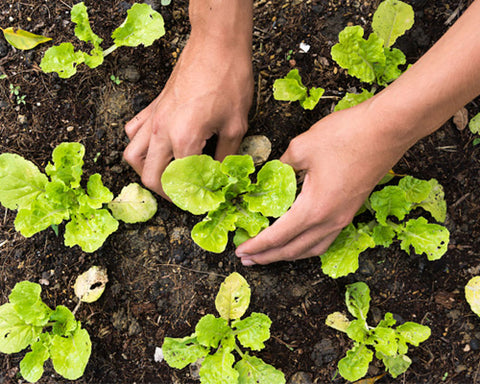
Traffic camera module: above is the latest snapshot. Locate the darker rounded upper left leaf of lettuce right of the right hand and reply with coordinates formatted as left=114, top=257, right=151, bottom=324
left=370, top=185, right=412, bottom=225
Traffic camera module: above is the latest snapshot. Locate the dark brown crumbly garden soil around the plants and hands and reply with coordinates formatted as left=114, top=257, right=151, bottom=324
left=0, top=0, right=480, bottom=384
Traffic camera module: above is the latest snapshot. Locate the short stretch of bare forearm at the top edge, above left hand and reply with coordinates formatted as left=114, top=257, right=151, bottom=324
left=189, top=0, right=253, bottom=55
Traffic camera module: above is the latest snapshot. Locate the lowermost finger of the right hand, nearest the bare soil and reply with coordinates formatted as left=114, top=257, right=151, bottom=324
left=241, top=226, right=338, bottom=266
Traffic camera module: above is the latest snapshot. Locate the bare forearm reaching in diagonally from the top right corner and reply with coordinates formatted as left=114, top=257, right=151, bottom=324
left=370, top=0, right=480, bottom=148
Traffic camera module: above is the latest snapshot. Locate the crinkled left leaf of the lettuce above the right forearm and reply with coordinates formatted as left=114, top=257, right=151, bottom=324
left=331, top=26, right=386, bottom=83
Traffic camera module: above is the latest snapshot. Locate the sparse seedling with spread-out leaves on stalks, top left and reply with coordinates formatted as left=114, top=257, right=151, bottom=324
left=40, top=2, right=165, bottom=78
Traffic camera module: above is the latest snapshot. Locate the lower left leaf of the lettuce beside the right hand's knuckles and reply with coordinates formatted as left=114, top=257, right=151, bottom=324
left=320, top=224, right=375, bottom=279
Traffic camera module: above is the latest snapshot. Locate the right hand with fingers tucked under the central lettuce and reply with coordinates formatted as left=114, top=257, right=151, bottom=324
left=236, top=101, right=411, bottom=265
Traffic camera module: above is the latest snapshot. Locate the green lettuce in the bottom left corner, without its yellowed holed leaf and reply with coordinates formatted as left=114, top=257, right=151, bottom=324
left=0, top=281, right=92, bottom=383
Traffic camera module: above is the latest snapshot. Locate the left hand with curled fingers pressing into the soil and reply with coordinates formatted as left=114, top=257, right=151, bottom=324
left=124, top=34, right=253, bottom=197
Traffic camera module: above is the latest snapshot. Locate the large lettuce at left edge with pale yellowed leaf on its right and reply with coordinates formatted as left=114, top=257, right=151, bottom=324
left=0, top=143, right=157, bottom=252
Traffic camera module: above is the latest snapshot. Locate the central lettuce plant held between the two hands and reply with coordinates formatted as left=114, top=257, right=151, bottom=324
left=162, top=155, right=296, bottom=253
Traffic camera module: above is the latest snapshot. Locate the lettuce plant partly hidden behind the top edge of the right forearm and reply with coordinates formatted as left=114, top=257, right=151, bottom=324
left=331, top=0, right=415, bottom=111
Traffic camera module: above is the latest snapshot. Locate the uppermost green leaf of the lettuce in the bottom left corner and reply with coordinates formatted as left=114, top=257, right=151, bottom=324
left=8, top=281, right=52, bottom=326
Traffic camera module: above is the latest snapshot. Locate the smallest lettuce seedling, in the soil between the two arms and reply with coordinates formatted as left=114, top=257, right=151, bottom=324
left=273, top=69, right=325, bottom=109
